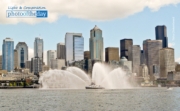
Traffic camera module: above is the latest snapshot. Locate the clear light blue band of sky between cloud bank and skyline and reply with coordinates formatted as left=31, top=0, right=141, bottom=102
left=0, top=4, right=180, bottom=62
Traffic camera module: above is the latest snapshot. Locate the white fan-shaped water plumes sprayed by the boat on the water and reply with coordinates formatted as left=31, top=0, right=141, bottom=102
left=39, top=63, right=131, bottom=89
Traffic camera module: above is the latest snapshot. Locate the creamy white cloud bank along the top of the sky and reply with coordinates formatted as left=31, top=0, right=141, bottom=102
left=0, top=0, right=180, bottom=24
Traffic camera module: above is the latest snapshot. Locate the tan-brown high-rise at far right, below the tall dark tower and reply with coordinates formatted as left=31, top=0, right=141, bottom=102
left=159, top=48, right=175, bottom=77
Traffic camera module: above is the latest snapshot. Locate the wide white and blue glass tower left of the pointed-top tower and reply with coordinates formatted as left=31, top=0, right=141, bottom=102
left=65, top=33, right=84, bottom=63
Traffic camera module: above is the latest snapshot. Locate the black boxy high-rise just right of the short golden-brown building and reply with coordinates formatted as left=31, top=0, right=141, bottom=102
left=120, top=39, right=133, bottom=59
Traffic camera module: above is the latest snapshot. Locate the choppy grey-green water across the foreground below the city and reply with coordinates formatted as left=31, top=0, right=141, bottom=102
left=0, top=88, right=180, bottom=111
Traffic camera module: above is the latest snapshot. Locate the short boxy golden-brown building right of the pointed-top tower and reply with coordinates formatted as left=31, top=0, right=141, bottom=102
left=105, top=47, right=119, bottom=62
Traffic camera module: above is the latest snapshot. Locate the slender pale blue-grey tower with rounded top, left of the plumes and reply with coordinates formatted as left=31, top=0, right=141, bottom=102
left=34, top=37, right=44, bottom=62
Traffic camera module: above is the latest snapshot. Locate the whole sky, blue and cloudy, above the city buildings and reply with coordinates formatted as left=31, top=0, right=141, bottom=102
left=0, top=0, right=180, bottom=62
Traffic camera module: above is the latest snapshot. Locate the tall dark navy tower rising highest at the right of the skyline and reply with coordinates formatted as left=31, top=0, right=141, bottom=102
left=155, top=25, right=168, bottom=48
